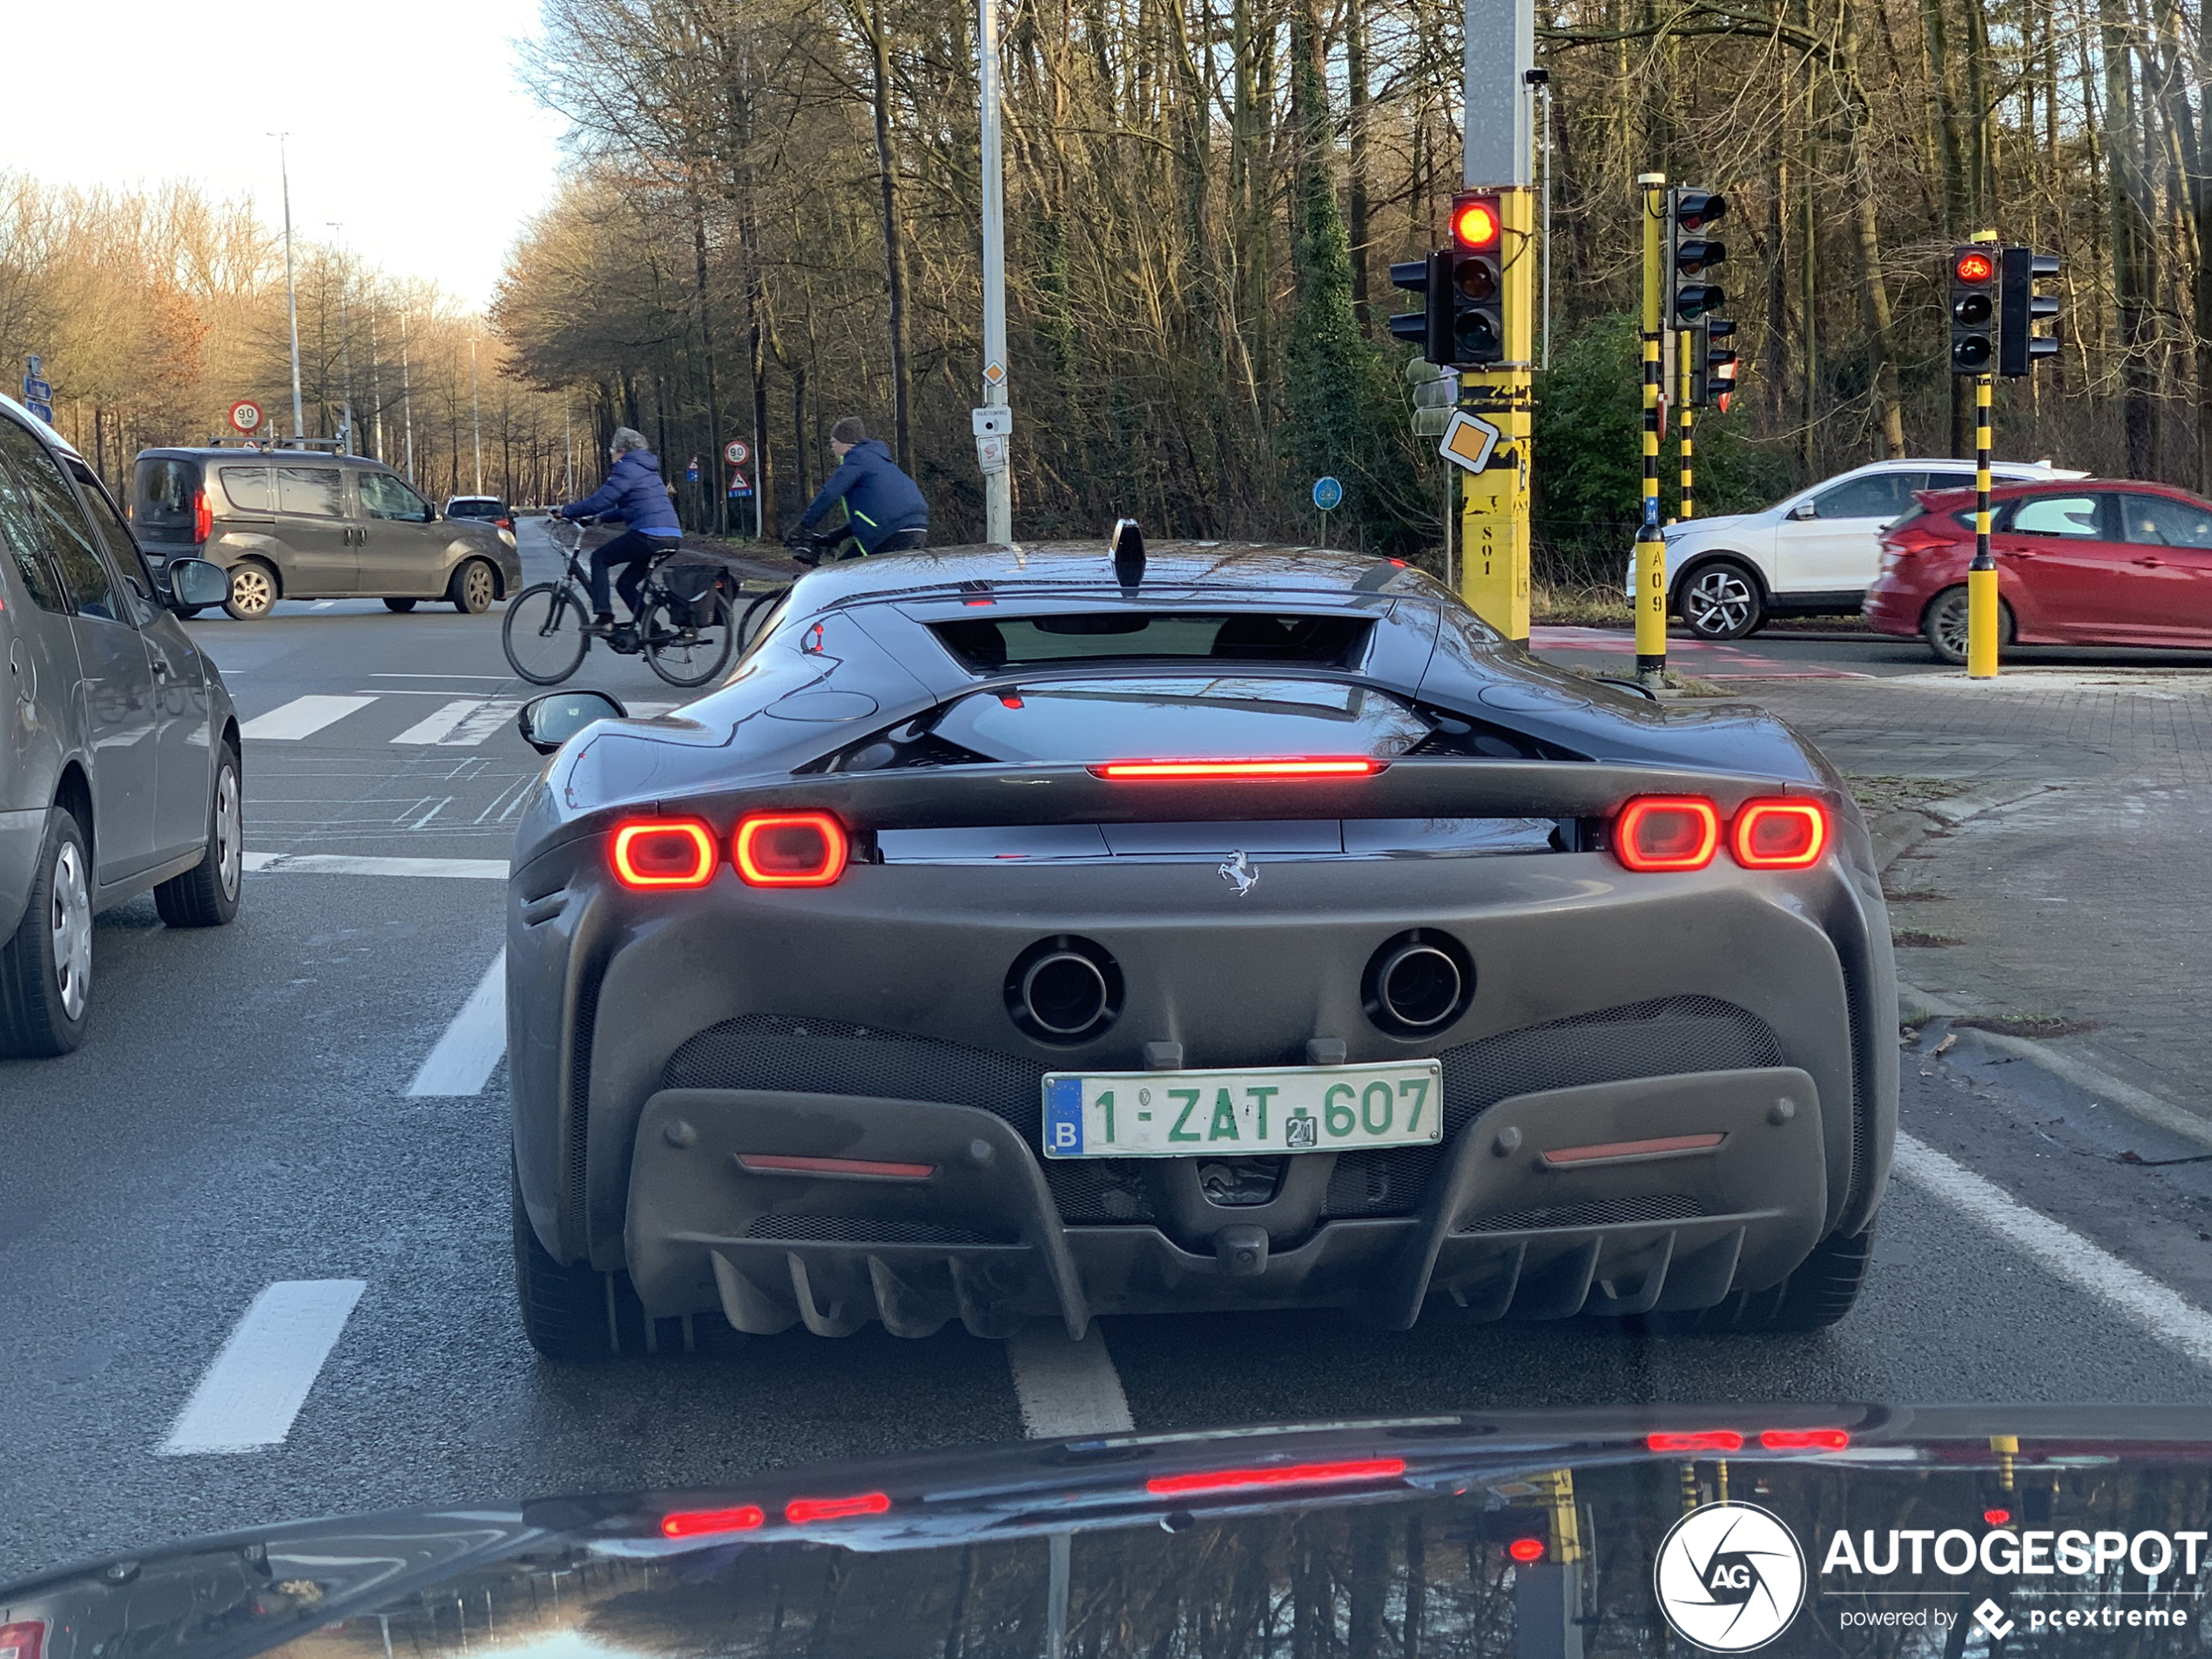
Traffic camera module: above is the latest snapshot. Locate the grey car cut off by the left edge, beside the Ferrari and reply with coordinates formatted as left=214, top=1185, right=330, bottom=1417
left=0, top=398, right=246, bottom=1055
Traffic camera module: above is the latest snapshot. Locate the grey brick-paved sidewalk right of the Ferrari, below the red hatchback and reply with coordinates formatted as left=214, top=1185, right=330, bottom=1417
left=1732, top=671, right=2212, bottom=1123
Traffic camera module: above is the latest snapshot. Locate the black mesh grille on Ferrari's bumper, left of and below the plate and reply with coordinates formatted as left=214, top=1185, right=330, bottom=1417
left=661, top=1013, right=1152, bottom=1221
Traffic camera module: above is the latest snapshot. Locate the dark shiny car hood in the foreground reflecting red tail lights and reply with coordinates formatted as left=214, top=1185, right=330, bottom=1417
left=12, top=1406, right=2212, bottom=1659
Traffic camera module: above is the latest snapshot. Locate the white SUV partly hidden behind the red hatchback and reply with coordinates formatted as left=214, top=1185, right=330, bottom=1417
left=1628, top=460, right=2088, bottom=639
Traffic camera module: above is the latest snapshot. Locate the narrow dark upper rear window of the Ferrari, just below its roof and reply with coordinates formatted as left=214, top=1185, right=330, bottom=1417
left=934, top=610, right=1373, bottom=672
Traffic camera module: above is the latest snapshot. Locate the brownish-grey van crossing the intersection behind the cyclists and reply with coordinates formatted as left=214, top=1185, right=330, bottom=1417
left=131, top=438, right=522, bottom=622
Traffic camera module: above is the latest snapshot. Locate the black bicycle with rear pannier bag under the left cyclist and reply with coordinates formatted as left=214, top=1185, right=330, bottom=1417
left=500, top=517, right=737, bottom=688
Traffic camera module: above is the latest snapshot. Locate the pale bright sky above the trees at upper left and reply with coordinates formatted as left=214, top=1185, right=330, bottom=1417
left=0, top=0, right=562, bottom=306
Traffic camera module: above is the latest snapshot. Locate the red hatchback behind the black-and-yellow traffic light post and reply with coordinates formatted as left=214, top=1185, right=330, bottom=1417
left=1865, top=478, right=2212, bottom=664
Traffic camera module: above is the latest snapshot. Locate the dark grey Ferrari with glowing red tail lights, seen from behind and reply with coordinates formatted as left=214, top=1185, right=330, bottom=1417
left=507, top=536, right=1898, bottom=1359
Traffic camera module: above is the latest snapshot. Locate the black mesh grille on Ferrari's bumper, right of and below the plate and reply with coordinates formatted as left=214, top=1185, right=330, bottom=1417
left=1323, top=998, right=1783, bottom=1217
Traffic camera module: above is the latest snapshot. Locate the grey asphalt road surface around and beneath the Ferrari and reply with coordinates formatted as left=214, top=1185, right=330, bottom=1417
left=0, top=533, right=2212, bottom=1581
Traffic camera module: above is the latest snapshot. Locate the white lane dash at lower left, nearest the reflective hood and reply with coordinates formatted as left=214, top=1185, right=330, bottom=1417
left=157, top=1278, right=368, bottom=1458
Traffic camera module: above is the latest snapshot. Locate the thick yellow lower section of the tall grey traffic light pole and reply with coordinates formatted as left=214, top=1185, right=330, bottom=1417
left=1455, top=185, right=1537, bottom=639
